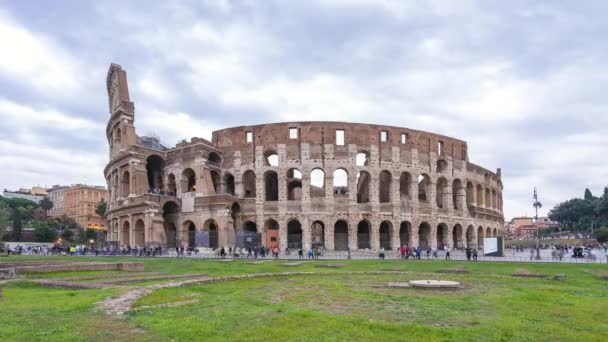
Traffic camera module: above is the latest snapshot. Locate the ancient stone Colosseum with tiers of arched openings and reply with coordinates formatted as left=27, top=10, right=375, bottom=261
left=104, top=64, right=504, bottom=252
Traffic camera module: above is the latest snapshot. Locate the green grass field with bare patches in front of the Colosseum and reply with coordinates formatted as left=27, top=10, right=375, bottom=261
left=0, top=257, right=608, bottom=341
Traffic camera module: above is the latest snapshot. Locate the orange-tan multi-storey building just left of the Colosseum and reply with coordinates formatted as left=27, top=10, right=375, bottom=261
left=63, top=184, right=108, bottom=230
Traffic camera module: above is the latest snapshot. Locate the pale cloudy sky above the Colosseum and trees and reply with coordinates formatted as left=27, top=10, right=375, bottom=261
left=0, top=0, right=608, bottom=217
